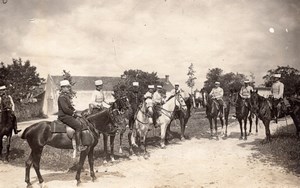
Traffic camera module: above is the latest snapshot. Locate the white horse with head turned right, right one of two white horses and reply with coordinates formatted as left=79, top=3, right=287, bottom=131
left=156, top=94, right=187, bottom=148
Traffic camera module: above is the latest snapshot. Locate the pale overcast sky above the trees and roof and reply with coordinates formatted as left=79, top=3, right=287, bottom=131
left=0, top=0, right=300, bottom=91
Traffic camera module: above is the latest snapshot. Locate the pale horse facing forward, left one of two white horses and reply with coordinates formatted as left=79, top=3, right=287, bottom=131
left=130, top=98, right=153, bottom=157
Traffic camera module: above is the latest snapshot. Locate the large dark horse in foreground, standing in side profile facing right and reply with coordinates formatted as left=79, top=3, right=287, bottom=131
left=21, top=99, right=127, bottom=186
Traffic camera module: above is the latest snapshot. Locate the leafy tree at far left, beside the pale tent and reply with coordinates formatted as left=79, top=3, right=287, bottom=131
left=0, top=58, right=45, bottom=102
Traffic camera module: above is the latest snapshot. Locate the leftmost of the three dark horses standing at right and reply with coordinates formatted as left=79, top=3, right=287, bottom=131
left=202, top=92, right=230, bottom=140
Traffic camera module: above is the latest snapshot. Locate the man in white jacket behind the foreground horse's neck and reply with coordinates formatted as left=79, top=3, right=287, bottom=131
left=89, top=80, right=110, bottom=113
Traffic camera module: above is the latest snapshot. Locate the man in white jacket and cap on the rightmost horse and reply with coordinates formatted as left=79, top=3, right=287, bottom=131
left=271, top=74, right=284, bottom=123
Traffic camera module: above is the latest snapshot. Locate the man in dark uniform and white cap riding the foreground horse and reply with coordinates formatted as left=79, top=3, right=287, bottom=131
left=58, top=80, right=87, bottom=151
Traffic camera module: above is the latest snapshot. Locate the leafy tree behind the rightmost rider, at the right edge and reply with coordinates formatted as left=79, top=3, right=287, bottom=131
left=263, top=66, right=300, bottom=96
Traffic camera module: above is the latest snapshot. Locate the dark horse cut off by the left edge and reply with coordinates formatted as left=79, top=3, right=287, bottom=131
left=0, top=110, right=17, bottom=161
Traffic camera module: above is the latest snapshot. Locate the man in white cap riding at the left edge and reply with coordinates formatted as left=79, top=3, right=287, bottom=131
left=0, top=86, right=21, bottom=134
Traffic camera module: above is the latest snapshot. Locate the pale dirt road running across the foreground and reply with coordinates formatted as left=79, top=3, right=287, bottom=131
left=0, top=117, right=300, bottom=188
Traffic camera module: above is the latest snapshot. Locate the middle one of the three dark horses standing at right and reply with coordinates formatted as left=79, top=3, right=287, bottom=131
left=231, top=92, right=258, bottom=140
